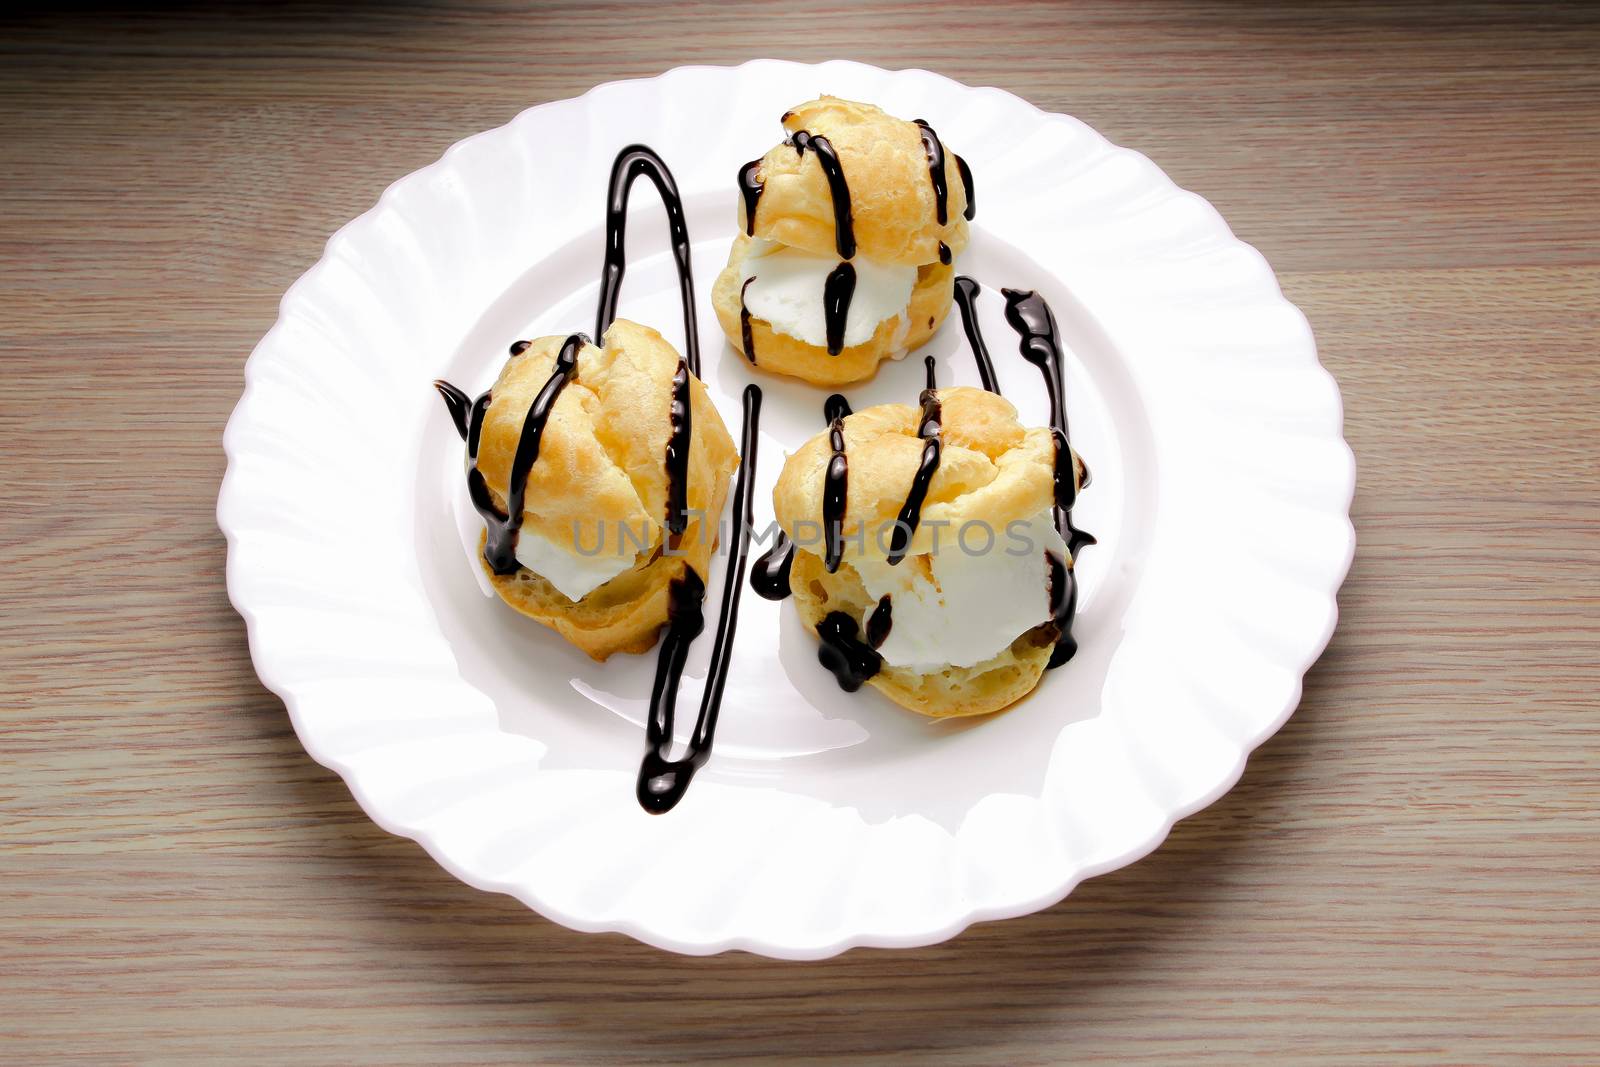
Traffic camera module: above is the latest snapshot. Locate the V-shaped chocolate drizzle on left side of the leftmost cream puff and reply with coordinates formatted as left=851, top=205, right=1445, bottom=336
left=434, top=333, right=589, bottom=574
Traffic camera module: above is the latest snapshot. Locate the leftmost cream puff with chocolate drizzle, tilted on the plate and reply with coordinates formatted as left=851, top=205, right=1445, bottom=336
left=435, top=318, right=739, bottom=659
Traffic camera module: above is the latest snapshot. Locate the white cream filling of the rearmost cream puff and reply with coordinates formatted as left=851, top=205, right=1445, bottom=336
left=739, top=238, right=917, bottom=349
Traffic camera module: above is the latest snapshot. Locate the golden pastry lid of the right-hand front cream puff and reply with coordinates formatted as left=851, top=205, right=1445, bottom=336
left=773, top=386, right=1075, bottom=561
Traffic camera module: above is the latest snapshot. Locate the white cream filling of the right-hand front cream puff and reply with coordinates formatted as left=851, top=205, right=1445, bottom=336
left=851, top=507, right=1067, bottom=670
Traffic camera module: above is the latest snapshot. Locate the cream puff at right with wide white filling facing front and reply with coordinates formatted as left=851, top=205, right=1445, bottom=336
left=773, top=371, right=1086, bottom=717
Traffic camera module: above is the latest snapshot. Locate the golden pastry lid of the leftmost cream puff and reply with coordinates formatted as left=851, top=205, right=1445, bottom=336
left=478, top=318, right=733, bottom=559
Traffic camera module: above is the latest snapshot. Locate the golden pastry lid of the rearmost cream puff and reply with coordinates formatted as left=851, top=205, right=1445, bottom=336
left=739, top=96, right=966, bottom=266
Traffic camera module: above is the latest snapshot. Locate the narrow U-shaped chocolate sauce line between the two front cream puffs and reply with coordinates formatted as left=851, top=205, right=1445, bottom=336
left=635, top=386, right=762, bottom=814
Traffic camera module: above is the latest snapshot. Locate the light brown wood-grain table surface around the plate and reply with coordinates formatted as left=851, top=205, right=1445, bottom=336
left=0, top=0, right=1600, bottom=1064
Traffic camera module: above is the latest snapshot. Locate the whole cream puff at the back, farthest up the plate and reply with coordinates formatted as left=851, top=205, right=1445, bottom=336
left=712, top=96, right=974, bottom=386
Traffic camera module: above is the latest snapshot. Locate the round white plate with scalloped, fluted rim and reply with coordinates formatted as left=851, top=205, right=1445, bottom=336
left=218, top=61, right=1355, bottom=958
